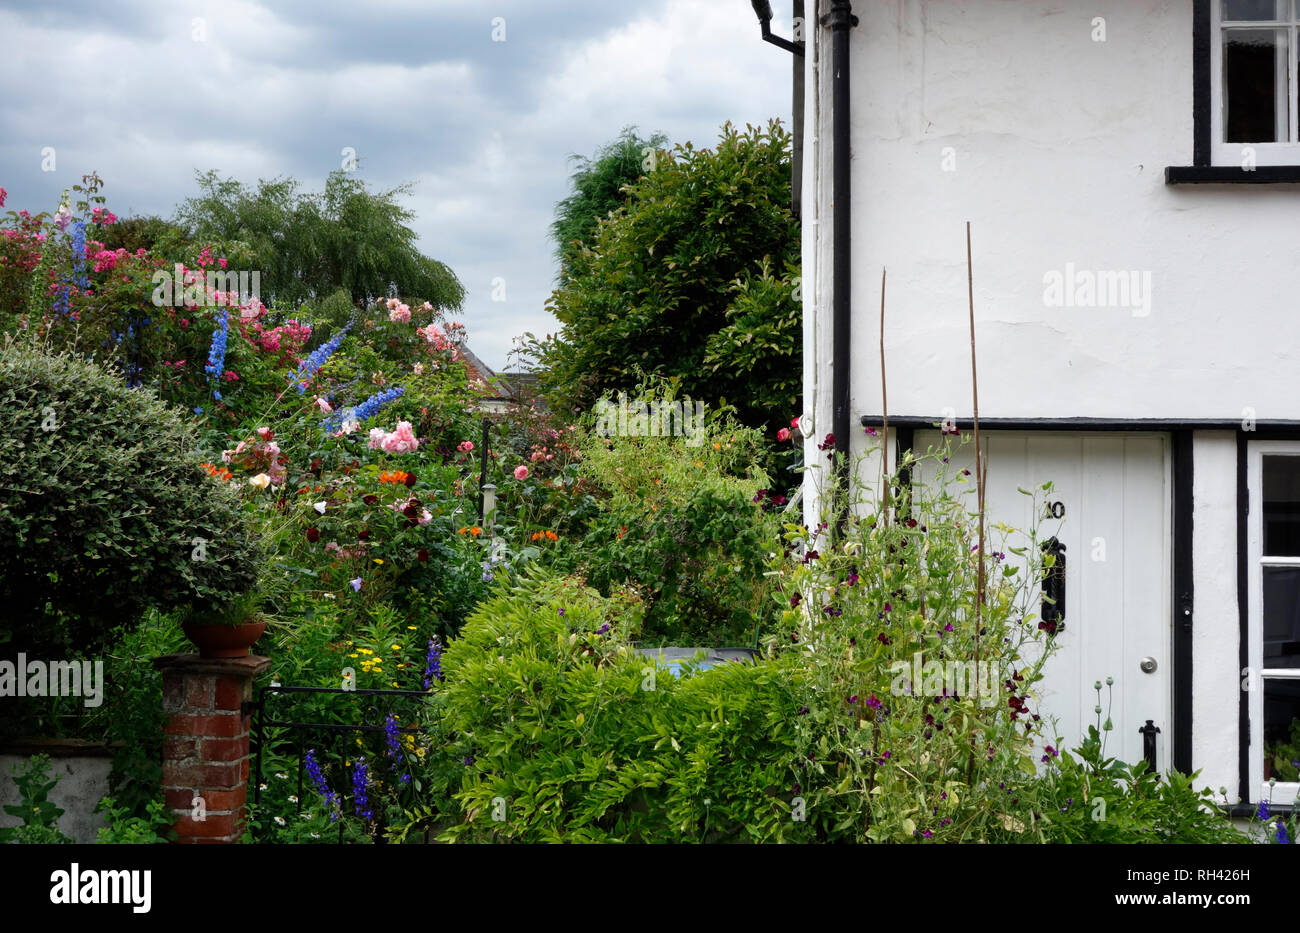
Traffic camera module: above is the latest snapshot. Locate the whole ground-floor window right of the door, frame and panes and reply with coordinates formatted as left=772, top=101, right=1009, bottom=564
left=1245, top=442, right=1300, bottom=804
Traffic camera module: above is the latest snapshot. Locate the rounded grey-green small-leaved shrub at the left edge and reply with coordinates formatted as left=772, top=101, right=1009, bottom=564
left=0, top=340, right=259, bottom=650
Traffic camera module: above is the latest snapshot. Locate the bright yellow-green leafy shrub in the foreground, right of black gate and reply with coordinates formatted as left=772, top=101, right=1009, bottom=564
left=404, top=570, right=806, bottom=842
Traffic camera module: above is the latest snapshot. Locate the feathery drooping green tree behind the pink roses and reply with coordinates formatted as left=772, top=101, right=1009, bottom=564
left=177, top=170, right=464, bottom=309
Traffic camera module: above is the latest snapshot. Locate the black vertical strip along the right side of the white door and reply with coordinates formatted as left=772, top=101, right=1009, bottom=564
left=1170, top=430, right=1195, bottom=774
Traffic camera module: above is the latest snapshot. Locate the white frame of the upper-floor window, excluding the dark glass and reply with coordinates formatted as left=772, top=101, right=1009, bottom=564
left=1210, top=0, right=1300, bottom=168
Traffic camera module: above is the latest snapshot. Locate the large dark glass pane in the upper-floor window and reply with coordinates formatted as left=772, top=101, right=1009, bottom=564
left=1223, top=29, right=1291, bottom=143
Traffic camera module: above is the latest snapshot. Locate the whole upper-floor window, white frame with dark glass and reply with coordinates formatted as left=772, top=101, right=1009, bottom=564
left=1210, top=0, right=1300, bottom=168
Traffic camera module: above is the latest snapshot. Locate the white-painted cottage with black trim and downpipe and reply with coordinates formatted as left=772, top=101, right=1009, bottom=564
left=769, top=0, right=1300, bottom=808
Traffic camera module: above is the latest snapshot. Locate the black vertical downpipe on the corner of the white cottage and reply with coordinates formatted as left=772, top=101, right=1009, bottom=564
left=824, top=0, right=858, bottom=531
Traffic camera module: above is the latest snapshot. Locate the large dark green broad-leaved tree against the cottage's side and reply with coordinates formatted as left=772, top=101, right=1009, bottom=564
left=532, top=121, right=801, bottom=444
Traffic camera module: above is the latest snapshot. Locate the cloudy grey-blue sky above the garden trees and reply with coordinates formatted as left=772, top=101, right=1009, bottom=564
left=0, top=0, right=790, bottom=369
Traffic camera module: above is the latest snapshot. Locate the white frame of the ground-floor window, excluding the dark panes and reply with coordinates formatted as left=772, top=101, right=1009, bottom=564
left=1242, top=441, right=1300, bottom=806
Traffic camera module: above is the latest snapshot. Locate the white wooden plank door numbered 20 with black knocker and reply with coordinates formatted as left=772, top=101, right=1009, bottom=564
left=913, top=430, right=1173, bottom=771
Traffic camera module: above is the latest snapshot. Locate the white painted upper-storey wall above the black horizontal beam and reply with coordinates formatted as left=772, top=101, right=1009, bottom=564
left=805, top=0, right=1300, bottom=431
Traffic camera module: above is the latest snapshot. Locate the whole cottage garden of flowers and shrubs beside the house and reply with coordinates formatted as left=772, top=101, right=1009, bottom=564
left=0, top=177, right=1296, bottom=843
